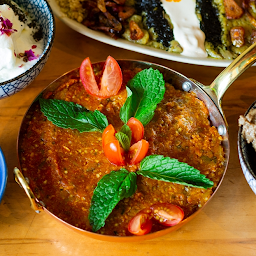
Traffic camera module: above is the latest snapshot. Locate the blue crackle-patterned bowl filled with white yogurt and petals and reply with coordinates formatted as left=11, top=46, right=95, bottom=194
left=0, top=0, right=55, bottom=98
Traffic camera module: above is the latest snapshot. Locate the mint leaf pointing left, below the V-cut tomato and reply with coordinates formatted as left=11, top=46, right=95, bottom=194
left=39, top=98, right=108, bottom=132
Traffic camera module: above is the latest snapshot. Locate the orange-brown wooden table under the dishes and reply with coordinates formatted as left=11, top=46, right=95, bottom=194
left=0, top=16, right=256, bottom=256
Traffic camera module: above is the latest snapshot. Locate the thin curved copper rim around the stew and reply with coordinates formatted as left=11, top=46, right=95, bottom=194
left=17, top=59, right=230, bottom=242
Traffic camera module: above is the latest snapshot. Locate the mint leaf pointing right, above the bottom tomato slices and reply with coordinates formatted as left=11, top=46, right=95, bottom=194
left=137, top=155, right=214, bottom=188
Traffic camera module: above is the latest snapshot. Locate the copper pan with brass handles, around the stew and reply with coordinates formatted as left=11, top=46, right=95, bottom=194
left=14, top=44, right=256, bottom=242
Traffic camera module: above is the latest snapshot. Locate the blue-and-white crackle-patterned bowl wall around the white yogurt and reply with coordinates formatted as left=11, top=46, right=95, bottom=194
left=0, top=0, right=55, bottom=99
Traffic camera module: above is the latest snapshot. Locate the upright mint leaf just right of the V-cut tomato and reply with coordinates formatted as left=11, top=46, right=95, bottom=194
left=120, top=68, right=165, bottom=126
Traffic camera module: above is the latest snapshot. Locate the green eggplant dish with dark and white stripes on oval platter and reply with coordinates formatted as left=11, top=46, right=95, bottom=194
left=56, top=0, right=256, bottom=59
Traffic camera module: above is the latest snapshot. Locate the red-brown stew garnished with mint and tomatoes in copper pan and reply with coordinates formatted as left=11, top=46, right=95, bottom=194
left=18, top=59, right=226, bottom=236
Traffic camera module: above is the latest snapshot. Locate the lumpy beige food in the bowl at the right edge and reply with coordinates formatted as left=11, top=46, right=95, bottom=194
left=238, top=106, right=256, bottom=151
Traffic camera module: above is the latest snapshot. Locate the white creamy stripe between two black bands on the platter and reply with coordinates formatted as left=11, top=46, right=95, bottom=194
left=161, top=0, right=207, bottom=57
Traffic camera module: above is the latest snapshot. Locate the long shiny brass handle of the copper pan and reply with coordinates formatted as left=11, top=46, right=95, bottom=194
left=207, top=43, right=256, bottom=114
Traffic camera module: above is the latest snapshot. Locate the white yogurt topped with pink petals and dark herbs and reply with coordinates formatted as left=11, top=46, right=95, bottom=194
left=0, top=2, right=44, bottom=83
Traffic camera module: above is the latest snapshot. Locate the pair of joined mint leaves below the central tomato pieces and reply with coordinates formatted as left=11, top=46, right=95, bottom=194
left=89, top=155, right=214, bottom=231
